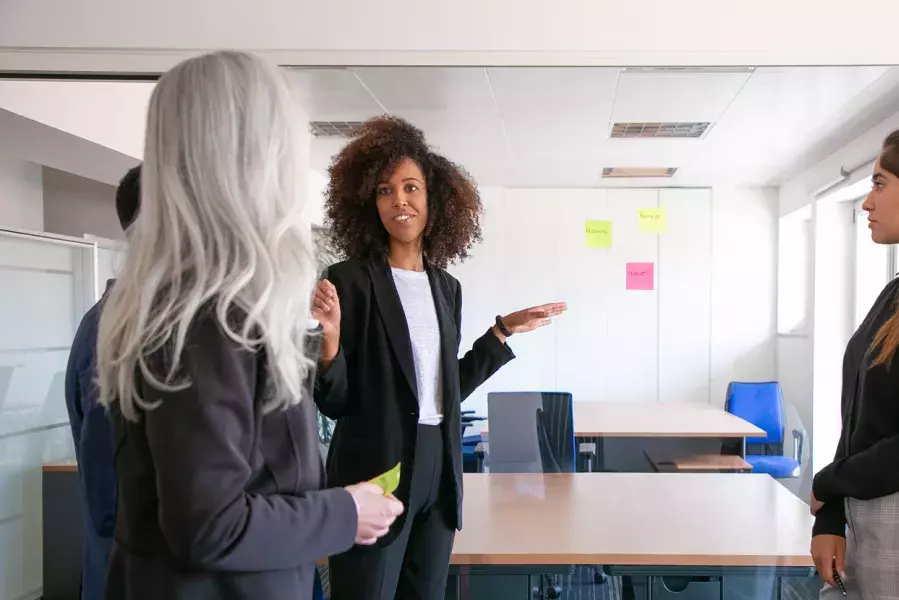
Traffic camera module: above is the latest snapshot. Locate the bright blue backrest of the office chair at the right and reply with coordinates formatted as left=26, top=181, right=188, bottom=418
left=724, top=381, right=784, bottom=444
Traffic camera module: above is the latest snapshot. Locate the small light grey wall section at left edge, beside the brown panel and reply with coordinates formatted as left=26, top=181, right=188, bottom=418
left=0, top=152, right=44, bottom=231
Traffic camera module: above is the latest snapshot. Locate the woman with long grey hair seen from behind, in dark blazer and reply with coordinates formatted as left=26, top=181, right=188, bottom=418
left=97, top=52, right=403, bottom=600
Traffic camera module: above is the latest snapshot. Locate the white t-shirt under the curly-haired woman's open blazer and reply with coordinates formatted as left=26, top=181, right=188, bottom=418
left=392, top=269, right=443, bottom=425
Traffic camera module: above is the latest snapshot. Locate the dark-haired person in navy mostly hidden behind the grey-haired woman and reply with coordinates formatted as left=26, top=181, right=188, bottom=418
left=66, top=166, right=140, bottom=600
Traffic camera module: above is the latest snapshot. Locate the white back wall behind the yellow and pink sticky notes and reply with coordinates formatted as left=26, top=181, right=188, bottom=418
left=450, top=188, right=776, bottom=413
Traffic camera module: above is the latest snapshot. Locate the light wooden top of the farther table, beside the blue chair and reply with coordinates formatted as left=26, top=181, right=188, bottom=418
left=481, top=402, right=765, bottom=438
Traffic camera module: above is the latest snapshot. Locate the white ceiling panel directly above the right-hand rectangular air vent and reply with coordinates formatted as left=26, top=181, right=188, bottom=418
left=612, top=72, right=751, bottom=123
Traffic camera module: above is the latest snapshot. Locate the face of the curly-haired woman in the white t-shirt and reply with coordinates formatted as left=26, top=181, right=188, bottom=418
left=375, top=158, right=428, bottom=245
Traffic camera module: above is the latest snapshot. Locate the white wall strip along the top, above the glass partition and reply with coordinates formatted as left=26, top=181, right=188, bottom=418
left=0, top=0, right=899, bottom=70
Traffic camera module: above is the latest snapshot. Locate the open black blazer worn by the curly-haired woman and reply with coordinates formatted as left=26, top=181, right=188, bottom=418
left=315, top=258, right=515, bottom=543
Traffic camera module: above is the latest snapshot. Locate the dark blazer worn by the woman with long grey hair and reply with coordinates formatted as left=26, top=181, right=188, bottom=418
left=106, top=314, right=356, bottom=600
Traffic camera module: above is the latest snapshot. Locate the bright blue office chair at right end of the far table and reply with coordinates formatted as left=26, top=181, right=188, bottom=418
left=724, top=381, right=805, bottom=479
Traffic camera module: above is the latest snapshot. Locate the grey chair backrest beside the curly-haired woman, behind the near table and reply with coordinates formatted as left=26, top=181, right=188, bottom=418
left=487, top=392, right=576, bottom=473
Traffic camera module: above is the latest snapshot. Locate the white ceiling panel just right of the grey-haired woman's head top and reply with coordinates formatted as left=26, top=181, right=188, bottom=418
left=287, top=69, right=383, bottom=121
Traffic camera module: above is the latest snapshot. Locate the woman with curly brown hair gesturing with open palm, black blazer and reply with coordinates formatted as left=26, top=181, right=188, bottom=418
left=313, top=117, right=566, bottom=600
